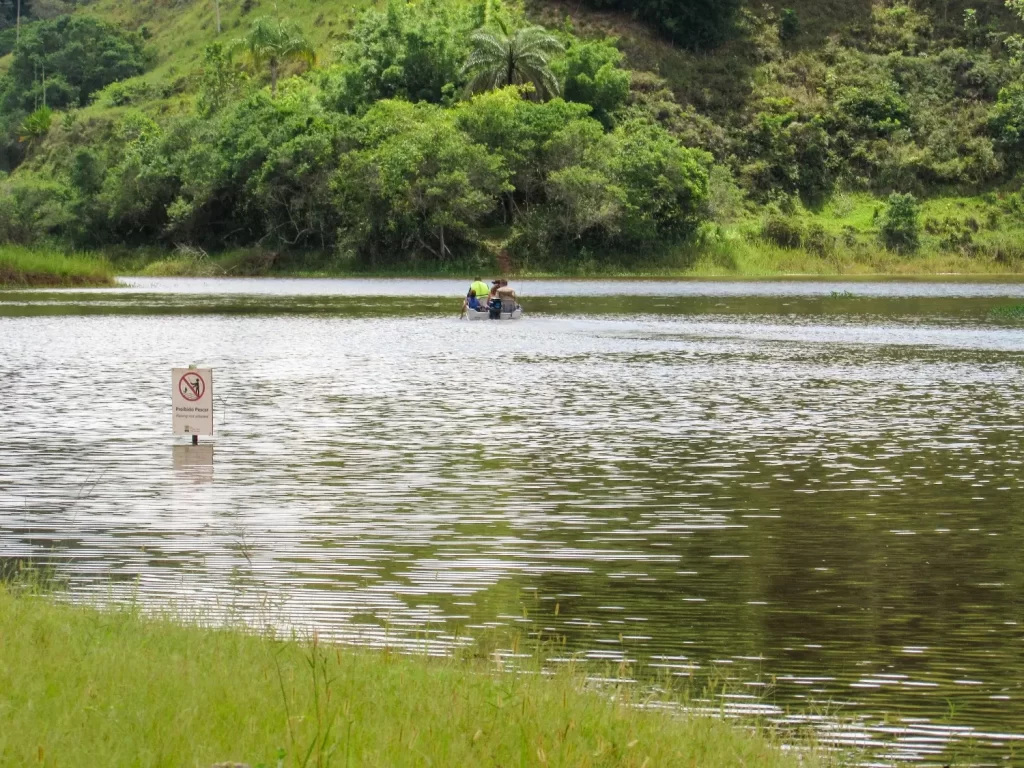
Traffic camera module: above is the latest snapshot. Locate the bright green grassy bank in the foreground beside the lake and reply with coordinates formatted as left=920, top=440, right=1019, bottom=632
left=0, top=587, right=818, bottom=768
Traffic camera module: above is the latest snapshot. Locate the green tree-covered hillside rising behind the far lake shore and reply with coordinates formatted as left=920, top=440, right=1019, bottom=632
left=0, top=0, right=1024, bottom=270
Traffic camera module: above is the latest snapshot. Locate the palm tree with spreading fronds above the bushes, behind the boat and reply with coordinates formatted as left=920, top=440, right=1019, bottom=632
left=464, top=19, right=564, bottom=99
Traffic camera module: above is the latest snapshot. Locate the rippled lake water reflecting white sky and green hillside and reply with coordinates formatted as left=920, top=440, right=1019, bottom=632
left=0, top=279, right=1024, bottom=766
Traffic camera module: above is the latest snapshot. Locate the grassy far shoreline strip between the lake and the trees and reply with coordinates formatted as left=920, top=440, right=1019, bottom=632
left=0, top=244, right=1024, bottom=290
